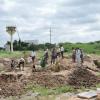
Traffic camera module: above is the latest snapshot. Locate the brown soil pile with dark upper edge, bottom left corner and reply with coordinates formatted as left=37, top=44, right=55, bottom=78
left=0, top=74, right=24, bottom=97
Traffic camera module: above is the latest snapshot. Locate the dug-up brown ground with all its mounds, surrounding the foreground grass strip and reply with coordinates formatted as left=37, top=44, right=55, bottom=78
left=0, top=55, right=100, bottom=100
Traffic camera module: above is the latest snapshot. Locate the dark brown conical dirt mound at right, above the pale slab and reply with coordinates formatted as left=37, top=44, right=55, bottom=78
left=68, top=67, right=98, bottom=88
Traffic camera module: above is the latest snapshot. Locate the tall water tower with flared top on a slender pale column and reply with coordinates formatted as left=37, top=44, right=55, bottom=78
left=6, top=26, right=16, bottom=52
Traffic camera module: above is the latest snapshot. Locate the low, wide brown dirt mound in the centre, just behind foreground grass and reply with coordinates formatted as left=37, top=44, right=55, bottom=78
left=31, top=72, right=67, bottom=88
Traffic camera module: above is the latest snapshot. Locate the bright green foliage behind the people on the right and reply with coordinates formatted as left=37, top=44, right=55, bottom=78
left=59, top=42, right=100, bottom=54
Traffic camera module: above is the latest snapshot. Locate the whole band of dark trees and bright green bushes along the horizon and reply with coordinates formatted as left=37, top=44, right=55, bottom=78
left=3, top=40, right=100, bottom=54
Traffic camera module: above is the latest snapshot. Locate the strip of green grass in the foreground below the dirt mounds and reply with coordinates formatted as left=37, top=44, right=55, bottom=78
left=26, top=85, right=75, bottom=96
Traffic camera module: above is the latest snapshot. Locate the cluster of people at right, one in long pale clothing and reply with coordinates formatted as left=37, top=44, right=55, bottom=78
left=72, top=48, right=84, bottom=66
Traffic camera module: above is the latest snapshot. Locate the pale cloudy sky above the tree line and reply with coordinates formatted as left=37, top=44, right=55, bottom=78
left=0, top=0, right=100, bottom=46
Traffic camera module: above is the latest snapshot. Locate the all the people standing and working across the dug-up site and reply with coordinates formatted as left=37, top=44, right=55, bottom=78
left=11, top=46, right=84, bottom=70
